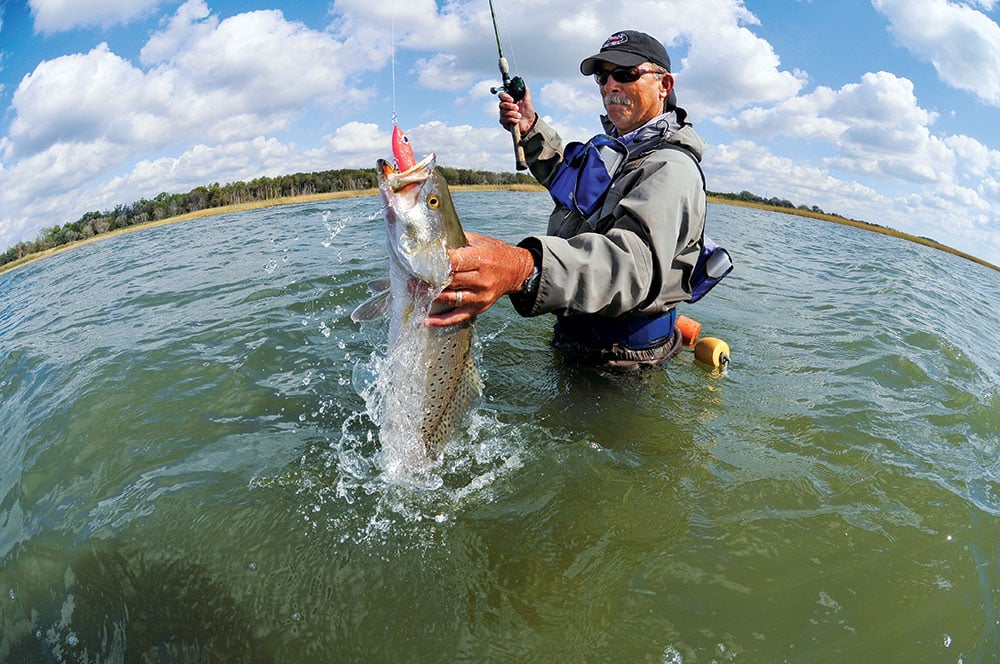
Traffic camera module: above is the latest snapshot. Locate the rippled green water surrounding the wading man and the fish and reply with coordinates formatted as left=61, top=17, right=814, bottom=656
left=0, top=193, right=1000, bottom=664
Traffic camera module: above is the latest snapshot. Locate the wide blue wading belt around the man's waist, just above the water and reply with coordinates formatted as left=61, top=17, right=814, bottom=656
left=556, top=309, right=677, bottom=350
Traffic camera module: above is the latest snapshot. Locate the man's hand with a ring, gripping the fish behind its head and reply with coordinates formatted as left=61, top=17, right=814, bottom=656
left=424, top=232, right=535, bottom=327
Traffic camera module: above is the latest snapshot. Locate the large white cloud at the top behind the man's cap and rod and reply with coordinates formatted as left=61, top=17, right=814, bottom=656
left=334, top=0, right=806, bottom=114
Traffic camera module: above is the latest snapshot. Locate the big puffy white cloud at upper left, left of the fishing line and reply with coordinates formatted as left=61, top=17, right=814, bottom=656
left=10, top=0, right=381, bottom=160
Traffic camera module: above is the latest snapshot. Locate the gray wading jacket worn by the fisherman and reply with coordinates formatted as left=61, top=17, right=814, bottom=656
left=511, top=113, right=706, bottom=317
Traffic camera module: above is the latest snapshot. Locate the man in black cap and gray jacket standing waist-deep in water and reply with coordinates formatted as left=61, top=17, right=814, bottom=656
left=427, top=30, right=706, bottom=368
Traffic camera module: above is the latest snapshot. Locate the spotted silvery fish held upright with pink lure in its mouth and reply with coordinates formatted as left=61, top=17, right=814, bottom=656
left=351, top=132, right=482, bottom=471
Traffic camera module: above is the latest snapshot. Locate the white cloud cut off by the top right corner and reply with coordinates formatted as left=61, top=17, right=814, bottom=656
left=872, top=0, right=1000, bottom=106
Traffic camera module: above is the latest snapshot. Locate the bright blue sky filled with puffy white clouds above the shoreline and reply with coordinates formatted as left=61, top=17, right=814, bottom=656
left=0, top=0, right=1000, bottom=264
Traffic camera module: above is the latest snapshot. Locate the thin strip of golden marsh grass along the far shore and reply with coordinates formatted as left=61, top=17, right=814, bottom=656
left=0, top=185, right=1000, bottom=274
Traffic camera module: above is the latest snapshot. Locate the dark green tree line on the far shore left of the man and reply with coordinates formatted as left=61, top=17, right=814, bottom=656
left=0, top=167, right=537, bottom=266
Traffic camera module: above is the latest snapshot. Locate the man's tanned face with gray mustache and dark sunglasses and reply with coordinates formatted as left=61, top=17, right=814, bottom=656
left=598, top=62, right=674, bottom=134
